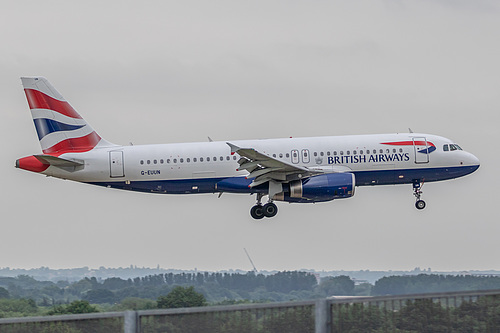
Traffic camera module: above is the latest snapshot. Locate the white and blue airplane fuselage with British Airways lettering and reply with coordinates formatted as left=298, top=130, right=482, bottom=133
left=42, top=133, right=479, bottom=193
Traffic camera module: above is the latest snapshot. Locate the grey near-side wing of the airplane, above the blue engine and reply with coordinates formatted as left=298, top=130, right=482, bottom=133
left=226, top=142, right=324, bottom=187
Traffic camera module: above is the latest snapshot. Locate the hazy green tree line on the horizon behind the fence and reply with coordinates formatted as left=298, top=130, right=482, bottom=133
left=0, top=271, right=500, bottom=317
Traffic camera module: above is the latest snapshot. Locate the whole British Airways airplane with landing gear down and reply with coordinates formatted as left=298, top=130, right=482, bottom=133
left=16, top=77, right=480, bottom=220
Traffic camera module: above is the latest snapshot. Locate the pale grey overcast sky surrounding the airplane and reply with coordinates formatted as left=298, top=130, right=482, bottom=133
left=0, top=0, right=500, bottom=270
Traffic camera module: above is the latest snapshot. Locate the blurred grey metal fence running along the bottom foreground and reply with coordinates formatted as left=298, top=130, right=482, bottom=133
left=0, top=290, right=500, bottom=333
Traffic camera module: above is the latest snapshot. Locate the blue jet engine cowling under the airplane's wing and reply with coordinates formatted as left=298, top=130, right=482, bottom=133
left=273, top=173, right=356, bottom=203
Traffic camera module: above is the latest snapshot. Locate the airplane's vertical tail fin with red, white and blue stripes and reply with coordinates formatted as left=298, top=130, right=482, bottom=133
left=21, top=77, right=113, bottom=155
